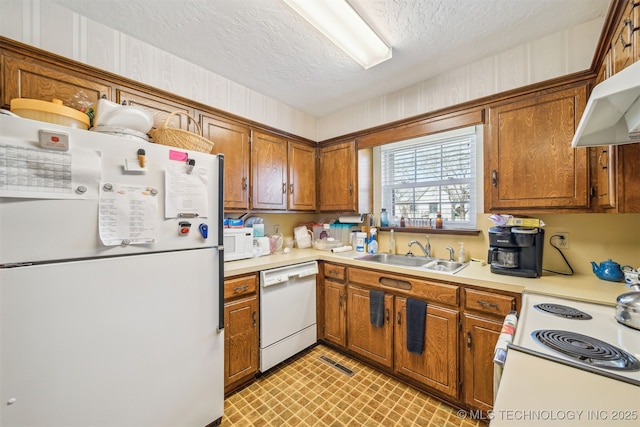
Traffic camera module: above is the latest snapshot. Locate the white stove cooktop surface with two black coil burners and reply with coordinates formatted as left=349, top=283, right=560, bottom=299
left=510, top=292, right=640, bottom=386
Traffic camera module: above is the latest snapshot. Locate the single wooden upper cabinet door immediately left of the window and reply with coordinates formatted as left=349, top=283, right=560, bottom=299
left=318, top=141, right=358, bottom=212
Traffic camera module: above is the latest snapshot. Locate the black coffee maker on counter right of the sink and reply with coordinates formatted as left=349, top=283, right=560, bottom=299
left=488, top=227, right=544, bottom=277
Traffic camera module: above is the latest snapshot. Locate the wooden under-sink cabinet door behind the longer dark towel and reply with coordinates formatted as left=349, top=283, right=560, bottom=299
left=394, top=297, right=458, bottom=398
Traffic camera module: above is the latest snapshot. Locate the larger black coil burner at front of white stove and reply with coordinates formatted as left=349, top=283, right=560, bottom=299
left=531, top=329, right=640, bottom=371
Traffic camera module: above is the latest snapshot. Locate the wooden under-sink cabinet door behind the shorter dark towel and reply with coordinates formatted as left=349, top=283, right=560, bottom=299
left=347, top=285, right=393, bottom=368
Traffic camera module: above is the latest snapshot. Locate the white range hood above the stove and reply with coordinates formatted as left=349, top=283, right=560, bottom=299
left=571, top=61, right=640, bottom=148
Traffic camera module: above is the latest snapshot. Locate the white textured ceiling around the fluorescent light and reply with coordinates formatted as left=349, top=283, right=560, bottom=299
left=54, top=0, right=610, bottom=117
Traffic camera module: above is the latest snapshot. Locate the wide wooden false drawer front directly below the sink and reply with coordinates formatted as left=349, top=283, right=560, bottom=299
left=349, top=267, right=458, bottom=306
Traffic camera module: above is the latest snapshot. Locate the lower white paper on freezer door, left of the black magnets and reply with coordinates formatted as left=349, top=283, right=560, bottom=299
left=98, top=183, right=158, bottom=246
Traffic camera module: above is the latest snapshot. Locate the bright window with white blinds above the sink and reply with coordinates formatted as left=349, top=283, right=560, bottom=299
left=380, top=127, right=476, bottom=228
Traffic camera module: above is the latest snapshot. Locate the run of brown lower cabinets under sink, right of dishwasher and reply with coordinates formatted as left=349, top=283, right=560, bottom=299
left=319, top=262, right=520, bottom=411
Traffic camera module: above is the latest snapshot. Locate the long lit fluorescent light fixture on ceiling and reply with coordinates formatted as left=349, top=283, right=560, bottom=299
left=283, top=0, right=391, bottom=69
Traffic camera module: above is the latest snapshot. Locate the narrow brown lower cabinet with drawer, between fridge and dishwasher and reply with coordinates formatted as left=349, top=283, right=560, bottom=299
left=224, top=274, right=260, bottom=394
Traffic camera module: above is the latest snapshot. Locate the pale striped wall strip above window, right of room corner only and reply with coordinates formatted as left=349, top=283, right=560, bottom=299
left=318, top=18, right=604, bottom=141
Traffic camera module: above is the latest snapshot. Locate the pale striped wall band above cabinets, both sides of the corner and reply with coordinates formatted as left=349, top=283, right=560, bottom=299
left=0, top=0, right=604, bottom=140
